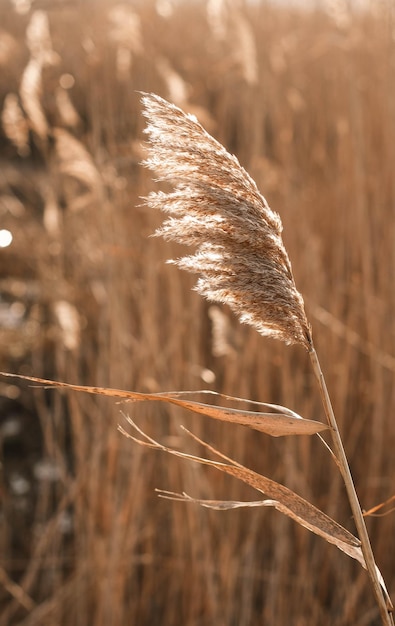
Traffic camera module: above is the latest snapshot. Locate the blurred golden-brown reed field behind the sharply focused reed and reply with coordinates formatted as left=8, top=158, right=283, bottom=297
left=0, top=0, right=395, bottom=626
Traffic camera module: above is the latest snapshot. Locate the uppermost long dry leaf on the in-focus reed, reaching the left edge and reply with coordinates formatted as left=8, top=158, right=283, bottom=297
left=0, top=372, right=328, bottom=437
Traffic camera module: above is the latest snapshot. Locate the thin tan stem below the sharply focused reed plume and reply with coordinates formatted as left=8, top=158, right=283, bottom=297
left=309, top=342, right=394, bottom=626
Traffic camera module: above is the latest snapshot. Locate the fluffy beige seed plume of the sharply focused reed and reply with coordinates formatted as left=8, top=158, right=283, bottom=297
left=142, top=94, right=311, bottom=349
